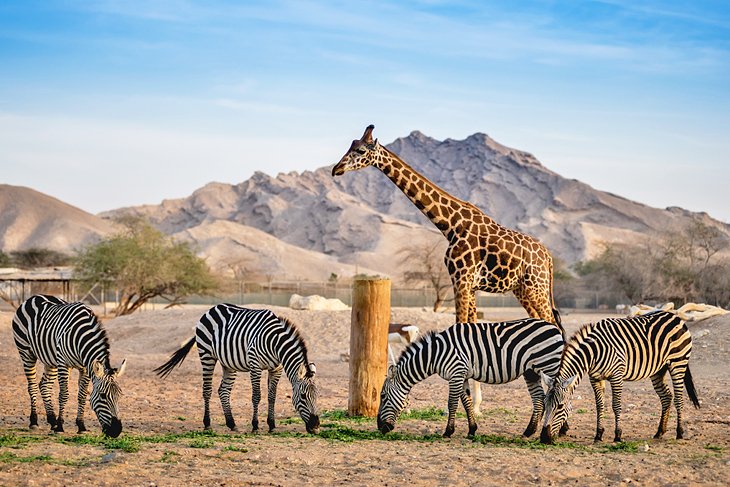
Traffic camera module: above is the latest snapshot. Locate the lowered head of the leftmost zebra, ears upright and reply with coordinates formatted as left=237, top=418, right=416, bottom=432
left=89, top=360, right=127, bottom=438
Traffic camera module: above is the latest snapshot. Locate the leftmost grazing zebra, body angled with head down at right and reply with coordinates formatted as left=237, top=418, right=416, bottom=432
left=12, top=295, right=127, bottom=438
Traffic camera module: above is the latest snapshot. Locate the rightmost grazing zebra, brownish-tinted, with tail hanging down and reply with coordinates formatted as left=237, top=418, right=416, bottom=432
left=540, top=311, right=700, bottom=443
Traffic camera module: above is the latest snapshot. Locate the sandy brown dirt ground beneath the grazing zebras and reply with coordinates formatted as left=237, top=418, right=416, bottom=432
left=0, top=307, right=730, bottom=486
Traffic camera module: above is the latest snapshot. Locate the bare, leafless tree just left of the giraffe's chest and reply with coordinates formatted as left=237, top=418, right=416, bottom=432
left=397, top=240, right=453, bottom=311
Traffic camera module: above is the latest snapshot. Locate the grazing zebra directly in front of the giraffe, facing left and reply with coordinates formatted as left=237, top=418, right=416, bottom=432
left=378, top=318, right=567, bottom=438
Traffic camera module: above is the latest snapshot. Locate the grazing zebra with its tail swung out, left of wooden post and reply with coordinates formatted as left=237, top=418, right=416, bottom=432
left=155, top=304, right=319, bottom=433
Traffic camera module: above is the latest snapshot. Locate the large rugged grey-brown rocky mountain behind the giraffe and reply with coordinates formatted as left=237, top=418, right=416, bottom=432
left=103, top=131, right=730, bottom=274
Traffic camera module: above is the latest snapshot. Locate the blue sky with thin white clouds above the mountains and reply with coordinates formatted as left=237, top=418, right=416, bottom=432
left=0, top=0, right=730, bottom=222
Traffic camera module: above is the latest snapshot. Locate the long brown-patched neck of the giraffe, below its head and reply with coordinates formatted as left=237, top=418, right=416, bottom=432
left=372, top=146, right=474, bottom=238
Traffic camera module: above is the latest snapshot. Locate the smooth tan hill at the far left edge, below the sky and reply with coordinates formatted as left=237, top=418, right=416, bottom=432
left=0, top=184, right=114, bottom=253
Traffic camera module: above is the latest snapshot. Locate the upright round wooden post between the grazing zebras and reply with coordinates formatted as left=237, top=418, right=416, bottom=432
left=347, top=277, right=390, bottom=418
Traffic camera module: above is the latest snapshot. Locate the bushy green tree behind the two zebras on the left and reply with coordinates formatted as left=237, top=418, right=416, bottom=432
left=74, top=218, right=218, bottom=316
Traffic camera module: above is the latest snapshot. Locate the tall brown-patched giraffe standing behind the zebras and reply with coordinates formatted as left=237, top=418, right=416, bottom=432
left=332, top=125, right=563, bottom=331
